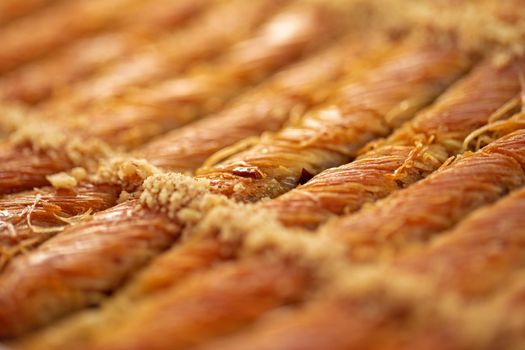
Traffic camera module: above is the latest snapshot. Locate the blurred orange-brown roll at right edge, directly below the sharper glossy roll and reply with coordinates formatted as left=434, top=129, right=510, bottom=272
left=394, top=185, right=525, bottom=300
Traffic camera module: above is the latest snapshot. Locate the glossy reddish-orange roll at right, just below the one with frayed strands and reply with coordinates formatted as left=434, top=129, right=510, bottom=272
left=323, top=130, right=525, bottom=260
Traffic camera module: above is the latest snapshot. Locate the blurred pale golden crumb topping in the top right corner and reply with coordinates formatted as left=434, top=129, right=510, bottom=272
left=363, top=0, right=525, bottom=57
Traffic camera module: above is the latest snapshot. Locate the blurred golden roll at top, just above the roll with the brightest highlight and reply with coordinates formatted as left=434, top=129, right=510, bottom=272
left=43, top=0, right=286, bottom=112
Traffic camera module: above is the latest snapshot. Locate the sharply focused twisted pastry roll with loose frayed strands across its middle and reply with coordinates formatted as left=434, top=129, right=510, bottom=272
left=262, top=59, right=524, bottom=228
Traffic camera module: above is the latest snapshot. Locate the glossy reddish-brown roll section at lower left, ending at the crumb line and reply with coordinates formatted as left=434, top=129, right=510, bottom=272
left=0, top=201, right=179, bottom=337
